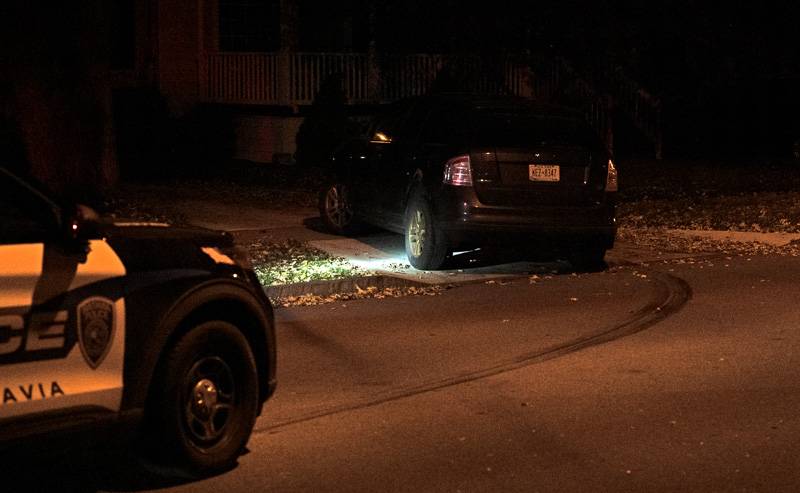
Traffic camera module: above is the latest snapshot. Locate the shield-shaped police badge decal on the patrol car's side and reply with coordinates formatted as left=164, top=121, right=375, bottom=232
left=78, top=296, right=114, bottom=370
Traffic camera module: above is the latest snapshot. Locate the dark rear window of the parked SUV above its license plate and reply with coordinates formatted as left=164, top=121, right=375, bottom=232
left=470, top=109, right=598, bottom=147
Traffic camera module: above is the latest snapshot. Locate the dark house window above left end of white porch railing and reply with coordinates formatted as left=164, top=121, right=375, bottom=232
left=219, top=0, right=280, bottom=51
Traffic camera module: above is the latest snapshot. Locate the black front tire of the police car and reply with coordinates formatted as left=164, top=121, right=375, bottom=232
left=147, top=320, right=258, bottom=476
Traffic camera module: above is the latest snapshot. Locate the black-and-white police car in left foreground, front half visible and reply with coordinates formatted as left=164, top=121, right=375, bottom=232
left=0, top=167, right=276, bottom=473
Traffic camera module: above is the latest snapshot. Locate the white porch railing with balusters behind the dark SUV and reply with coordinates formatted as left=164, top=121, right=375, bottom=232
left=201, top=53, right=533, bottom=106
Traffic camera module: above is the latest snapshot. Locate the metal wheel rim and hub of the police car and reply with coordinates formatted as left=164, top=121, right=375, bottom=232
left=185, top=357, right=234, bottom=445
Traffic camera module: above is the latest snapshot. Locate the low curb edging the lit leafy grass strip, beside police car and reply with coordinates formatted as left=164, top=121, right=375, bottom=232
left=264, top=275, right=434, bottom=298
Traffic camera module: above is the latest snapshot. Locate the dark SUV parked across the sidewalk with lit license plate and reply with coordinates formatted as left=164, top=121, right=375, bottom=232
left=319, top=95, right=617, bottom=270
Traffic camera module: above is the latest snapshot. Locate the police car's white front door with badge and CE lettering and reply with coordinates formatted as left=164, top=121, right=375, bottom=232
left=0, top=172, right=125, bottom=419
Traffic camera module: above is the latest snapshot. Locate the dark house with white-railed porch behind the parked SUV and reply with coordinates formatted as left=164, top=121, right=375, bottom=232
left=112, top=0, right=531, bottom=168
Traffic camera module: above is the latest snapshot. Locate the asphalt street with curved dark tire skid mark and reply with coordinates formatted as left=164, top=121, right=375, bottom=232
left=37, top=252, right=800, bottom=492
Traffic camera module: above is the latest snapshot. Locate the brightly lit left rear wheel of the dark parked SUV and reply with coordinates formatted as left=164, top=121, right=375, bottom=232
left=404, top=194, right=448, bottom=270
